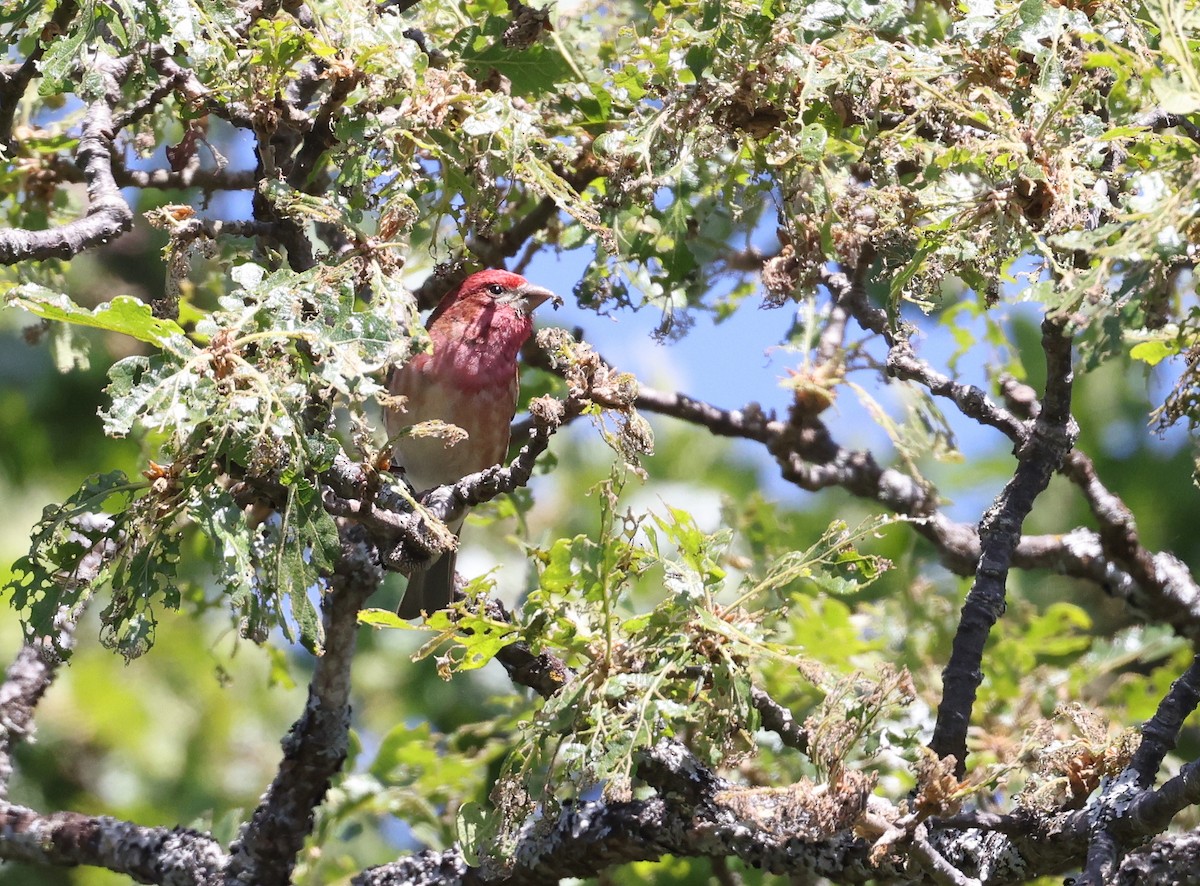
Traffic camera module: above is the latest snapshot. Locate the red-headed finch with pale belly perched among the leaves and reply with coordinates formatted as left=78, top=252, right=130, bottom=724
left=388, top=270, right=562, bottom=618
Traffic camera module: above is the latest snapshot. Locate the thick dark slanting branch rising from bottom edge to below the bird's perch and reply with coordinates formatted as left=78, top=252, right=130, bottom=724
left=227, top=526, right=383, bottom=886
